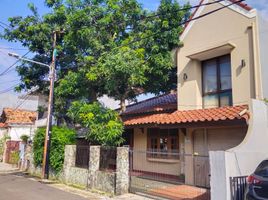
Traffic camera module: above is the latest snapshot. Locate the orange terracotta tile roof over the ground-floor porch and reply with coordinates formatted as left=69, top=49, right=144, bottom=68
left=123, top=105, right=249, bottom=126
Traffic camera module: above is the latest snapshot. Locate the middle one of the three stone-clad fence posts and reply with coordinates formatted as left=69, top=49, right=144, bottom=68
left=88, top=146, right=100, bottom=189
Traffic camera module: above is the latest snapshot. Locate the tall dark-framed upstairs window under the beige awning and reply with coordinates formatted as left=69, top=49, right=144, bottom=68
left=202, top=55, right=233, bottom=108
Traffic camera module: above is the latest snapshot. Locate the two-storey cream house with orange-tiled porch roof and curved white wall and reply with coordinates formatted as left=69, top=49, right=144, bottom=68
left=122, top=0, right=268, bottom=200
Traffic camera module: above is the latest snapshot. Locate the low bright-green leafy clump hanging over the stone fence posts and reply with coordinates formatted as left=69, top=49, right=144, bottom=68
left=68, top=101, right=123, bottom=146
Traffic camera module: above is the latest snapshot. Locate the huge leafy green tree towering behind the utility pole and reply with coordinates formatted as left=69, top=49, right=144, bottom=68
left=2, top=0, right=189, bottom=115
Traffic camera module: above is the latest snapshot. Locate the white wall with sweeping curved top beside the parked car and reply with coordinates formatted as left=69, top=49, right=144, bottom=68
left=209, top=100, right=268, bottom=200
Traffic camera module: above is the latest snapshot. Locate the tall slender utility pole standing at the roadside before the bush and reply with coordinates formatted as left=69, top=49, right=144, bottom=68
left=42, top=31, right=57, bottom=179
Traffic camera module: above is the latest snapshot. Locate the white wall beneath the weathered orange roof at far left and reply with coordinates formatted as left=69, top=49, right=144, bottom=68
left=8, top=125, right=34, bottom=141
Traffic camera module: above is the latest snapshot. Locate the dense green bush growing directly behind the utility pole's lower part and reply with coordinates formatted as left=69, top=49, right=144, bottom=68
left=33, top=127, right=76, bottom=173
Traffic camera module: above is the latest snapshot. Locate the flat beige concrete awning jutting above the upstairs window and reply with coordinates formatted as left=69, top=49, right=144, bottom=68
left=187, top=43, right=235, bottom=61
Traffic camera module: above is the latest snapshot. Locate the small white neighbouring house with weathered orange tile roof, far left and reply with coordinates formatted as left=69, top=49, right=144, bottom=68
left=1, top=108, right=37, bottom=141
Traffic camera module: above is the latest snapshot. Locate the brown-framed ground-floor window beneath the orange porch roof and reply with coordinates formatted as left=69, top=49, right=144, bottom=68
left=147, top=128, right=179, bottom=159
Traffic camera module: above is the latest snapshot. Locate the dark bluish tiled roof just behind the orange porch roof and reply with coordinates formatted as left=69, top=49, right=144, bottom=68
left=121, top=92, right=177, bottom=115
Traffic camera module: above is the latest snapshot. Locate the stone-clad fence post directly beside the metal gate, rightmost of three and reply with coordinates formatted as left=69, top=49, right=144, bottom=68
left=115, top=147, right=129, bottom=195
